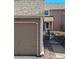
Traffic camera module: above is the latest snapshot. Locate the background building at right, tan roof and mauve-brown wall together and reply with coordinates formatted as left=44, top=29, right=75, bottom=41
left=44, top=3, right=65, bottom=31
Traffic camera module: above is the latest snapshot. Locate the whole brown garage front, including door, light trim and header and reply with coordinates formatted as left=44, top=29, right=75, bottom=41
left=14, top=18, right=40, bottom=56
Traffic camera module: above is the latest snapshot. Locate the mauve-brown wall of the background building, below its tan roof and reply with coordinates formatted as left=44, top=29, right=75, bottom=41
left=50, top=9, right=65, bottom=31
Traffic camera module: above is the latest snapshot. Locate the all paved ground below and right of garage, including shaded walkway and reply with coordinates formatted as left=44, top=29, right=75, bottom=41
left=14, top=40, right=65, bottom=59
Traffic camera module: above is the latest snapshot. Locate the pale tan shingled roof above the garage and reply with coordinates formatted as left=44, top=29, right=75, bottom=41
left=14, top=0, right=43, bottom=16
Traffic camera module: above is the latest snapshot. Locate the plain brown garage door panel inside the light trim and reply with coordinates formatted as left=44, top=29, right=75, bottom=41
left=14, top=22, right=38, bottom=55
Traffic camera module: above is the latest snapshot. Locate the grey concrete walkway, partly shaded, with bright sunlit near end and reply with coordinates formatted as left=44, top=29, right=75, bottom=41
left=50, top=40, right=65, bottom=59
